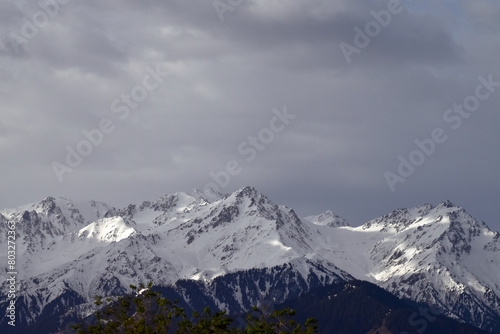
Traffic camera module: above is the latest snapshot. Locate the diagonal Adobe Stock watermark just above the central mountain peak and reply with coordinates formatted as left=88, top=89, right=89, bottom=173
left=203, top=106, right=297, bottom=192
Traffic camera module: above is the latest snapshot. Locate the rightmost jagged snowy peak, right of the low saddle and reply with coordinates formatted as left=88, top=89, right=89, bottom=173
left=322, top=201, right=500, bottom=332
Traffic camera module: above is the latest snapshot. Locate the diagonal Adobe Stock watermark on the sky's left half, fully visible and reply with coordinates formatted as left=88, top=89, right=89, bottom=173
left=51, top=64, right=170, bottom=182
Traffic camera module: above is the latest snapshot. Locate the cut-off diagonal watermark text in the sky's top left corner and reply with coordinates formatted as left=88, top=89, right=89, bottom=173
left=2, top=0, right=74, bottom=54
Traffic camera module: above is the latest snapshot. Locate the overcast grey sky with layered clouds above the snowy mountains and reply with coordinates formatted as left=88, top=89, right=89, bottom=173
left=0, top=0, right=500, bottom=230
